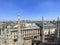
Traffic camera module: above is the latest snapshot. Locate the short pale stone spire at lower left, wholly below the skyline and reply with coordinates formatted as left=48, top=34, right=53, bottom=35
left=5, top=26, right=13, bottom=45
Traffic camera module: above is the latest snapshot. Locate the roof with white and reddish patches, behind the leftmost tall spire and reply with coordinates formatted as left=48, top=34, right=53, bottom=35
left=7, top=23, right=40, bottom=29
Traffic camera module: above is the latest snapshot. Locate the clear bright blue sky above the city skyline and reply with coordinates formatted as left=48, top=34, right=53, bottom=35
left=0, top=0, right=60, bottom=20
